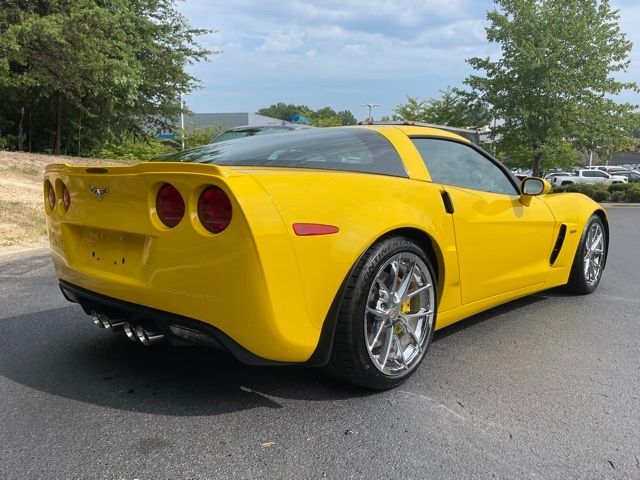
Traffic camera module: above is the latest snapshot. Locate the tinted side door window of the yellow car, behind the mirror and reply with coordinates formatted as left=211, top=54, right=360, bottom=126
left=412, top=138, right=518, bottom=195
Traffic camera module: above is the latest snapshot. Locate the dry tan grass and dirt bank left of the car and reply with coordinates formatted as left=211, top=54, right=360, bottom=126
left=0, top=150, right=130, bottom=251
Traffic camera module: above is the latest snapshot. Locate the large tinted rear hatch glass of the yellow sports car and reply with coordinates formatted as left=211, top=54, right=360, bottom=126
left=155, top=128, right=407, bottom=177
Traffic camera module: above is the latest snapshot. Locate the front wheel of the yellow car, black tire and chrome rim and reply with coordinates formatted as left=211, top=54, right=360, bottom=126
left=566, top=215, right=609, bottom=295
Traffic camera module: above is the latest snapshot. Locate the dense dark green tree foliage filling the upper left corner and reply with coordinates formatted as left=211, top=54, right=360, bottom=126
left=0, top=0, right=213, bottom=155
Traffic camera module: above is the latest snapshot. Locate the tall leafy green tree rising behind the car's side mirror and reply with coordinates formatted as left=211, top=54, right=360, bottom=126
left=463, top=0, right=638, bottom=175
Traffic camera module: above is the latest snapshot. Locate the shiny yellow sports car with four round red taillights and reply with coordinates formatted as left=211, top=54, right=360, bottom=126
left=44, top=125, right=609, bottom=389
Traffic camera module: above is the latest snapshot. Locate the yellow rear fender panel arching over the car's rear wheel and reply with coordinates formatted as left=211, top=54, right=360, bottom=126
left=246, top=171, right=460, bottom=336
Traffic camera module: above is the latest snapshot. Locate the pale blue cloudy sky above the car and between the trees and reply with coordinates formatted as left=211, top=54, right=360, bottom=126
left=178, top=0, right=640, bottom=120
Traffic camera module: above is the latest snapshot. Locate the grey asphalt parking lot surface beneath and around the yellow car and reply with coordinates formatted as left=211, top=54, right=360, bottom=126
left=0, top=208, right=640, bottom=480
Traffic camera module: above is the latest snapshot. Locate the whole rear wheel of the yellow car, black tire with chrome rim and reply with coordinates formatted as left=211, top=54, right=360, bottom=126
left=327, top=237, right=437, bottom=390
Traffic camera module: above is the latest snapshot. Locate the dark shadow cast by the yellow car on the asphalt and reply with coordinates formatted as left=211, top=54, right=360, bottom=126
left=0, top=296, right=545, bottom=416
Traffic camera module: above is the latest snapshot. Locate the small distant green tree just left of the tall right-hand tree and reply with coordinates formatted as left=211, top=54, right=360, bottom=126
left=394, top=88, right=491, bottom=130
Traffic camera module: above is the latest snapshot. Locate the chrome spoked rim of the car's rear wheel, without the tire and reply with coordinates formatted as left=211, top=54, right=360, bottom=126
left=364, top=252, right=434, bottom=377
